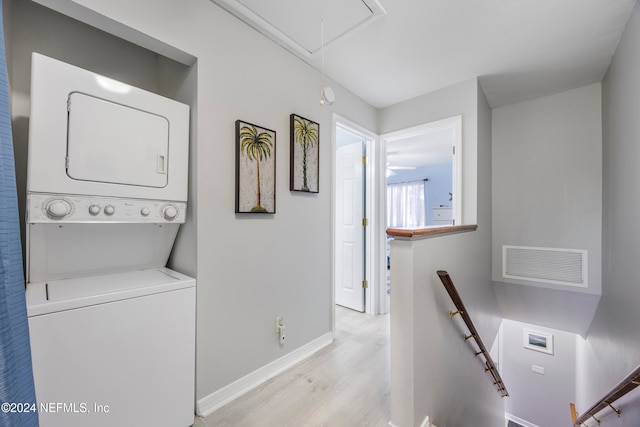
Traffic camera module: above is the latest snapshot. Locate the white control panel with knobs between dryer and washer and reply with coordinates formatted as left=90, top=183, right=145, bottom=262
left=27, top=193, right=187, bottom=223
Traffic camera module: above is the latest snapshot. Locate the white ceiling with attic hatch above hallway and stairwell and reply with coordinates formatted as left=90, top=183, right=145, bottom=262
left=212, top=0, right=636, bottom=108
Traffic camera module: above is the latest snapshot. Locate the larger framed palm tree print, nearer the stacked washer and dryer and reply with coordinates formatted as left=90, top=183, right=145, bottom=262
left=236, top=120, right=276, bottom=214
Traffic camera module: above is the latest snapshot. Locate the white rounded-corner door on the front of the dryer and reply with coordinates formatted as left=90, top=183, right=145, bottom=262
left=67, top=92, right=169, bottom=188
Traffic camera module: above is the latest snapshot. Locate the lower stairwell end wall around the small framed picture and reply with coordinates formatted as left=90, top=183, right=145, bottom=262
left=500, top=320, right=576, bottom=427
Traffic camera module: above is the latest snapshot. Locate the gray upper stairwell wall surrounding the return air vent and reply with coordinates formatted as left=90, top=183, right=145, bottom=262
left=493, top=84, right=602, bottom=295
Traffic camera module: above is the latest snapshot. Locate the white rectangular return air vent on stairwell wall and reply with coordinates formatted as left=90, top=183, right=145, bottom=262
left=502, top=246, right=587, bottom=288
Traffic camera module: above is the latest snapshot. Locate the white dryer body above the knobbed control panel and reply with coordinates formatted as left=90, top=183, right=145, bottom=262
left=27, top=53, right=189, bottom=202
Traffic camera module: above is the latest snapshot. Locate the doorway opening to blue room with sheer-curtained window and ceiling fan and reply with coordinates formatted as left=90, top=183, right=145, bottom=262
left=378, top=116, right=462, bottom=314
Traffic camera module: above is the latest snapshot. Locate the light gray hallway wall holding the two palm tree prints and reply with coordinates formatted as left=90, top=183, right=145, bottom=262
left=22, top=0, right=376, bottom=400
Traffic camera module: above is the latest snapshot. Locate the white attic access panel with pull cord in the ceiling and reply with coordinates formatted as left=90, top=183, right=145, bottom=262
left=212, top=0, right=386, bottom=57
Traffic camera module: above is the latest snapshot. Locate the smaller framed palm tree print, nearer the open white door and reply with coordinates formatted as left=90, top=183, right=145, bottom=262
left=289, top=114, right=320, bottom=193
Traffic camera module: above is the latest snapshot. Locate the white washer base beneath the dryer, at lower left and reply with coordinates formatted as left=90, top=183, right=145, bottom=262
left=27, top=268, right=195, bottom=427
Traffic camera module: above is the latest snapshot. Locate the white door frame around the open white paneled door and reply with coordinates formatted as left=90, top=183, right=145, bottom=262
left=331, top=113, right=381, bottom=333
